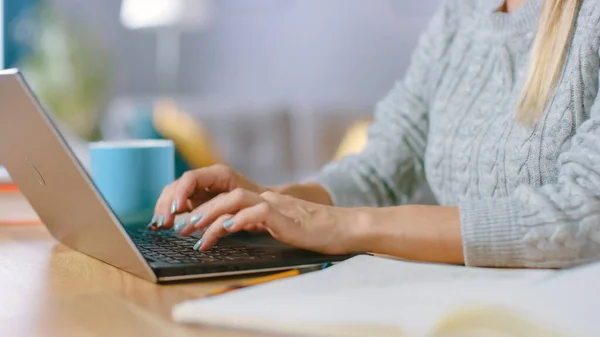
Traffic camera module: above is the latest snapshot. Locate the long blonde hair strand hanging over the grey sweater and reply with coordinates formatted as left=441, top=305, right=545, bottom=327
left=516, top=0, right=581, bottom=126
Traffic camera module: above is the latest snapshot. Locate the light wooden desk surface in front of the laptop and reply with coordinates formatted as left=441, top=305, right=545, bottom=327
left=0, top=224, right=262, bottom=337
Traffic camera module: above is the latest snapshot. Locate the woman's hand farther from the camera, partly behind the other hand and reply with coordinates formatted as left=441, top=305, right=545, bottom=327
left=148, top=164, right=268, bottom=230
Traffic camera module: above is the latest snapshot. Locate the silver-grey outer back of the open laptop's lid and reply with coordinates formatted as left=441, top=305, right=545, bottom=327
left=0, top=69, right=156, bottom=282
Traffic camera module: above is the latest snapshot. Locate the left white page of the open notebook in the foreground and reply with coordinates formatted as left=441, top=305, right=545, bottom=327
left=173, top=256, right=553, bottom=336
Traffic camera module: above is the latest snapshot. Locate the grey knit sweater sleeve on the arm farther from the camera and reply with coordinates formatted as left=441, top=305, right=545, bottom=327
left=313, top=3, right=454, bottom=207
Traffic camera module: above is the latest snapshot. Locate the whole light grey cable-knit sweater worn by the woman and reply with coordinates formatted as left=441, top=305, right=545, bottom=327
left=315, top=0, right=600, bottom=267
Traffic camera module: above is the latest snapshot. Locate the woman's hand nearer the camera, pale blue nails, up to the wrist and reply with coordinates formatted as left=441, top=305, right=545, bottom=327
left=181, top=189, right=357, bottom=254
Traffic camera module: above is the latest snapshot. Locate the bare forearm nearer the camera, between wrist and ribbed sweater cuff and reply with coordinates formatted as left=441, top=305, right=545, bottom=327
left=349, top=205, right=464, bottom=264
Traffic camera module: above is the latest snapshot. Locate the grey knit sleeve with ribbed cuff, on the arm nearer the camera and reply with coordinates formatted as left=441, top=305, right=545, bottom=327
left=459, top=61, right=600, bottom=268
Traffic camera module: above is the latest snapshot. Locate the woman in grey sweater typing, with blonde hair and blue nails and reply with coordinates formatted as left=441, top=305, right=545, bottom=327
left=146, top=0, right=600, bottom=268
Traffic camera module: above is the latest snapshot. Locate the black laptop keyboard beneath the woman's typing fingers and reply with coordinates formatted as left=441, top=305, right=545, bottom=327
left=127, top=228, right=277, bottom=264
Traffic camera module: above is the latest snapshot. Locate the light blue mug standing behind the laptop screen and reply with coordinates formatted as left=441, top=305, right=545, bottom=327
left=90, top=140, right=175, bottom=226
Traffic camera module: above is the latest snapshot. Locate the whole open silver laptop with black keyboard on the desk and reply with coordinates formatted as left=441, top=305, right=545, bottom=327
left=0, top=69, right=350, bottom=283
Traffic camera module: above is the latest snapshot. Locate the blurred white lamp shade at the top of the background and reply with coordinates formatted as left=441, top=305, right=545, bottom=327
left=121, top=0, right=212, bottom=30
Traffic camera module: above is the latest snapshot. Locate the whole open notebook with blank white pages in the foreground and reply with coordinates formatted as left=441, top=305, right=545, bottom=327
left=172, top=255, right=600, bottom=337
